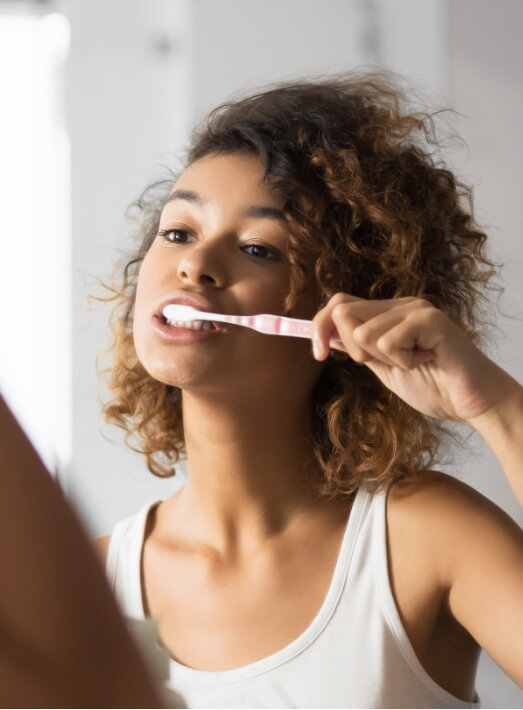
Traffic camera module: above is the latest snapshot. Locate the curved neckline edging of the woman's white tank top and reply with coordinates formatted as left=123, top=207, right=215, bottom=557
left=135, top=487, right=372, bottom=684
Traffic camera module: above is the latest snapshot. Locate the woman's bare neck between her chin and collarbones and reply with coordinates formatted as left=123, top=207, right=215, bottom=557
left=173, top=392, right=322, bottom=548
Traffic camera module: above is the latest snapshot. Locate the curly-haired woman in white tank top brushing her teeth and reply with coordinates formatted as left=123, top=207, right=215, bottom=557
left=96, top=74, right=523, bottom=707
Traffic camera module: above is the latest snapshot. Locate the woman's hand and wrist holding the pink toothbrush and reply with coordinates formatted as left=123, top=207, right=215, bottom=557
left=313, top=293, right=519, bottom=426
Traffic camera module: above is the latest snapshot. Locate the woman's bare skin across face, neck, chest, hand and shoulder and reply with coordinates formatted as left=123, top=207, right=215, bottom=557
left=96, top=155, right=523, bottom=700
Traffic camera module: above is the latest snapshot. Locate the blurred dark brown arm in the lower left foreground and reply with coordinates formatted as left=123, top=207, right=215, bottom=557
left=0, top=397, right=162, bottom=708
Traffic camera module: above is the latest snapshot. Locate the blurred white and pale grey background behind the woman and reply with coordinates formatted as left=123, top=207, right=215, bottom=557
left=0, top=0, right=523, bottom=708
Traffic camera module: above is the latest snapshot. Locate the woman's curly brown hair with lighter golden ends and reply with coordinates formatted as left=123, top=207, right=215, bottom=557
left=99, top=71, right=495, bottom=497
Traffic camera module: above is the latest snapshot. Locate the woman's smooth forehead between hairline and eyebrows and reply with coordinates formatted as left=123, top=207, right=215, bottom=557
left=171, top=153, right=283, bottom=208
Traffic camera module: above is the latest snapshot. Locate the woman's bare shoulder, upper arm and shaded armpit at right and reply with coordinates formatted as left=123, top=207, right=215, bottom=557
left=387, top=471, right=523, bottom=697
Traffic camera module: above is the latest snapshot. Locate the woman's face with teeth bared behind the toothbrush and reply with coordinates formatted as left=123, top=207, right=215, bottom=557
left=134, top=154, right=320, bottom=392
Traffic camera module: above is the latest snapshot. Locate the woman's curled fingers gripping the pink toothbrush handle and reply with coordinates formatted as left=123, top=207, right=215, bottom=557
left=313, top=294, right=438, bottom=369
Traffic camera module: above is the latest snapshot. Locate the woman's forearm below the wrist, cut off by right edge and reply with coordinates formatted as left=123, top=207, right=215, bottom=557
left=469, top=373, right=523, bottom=506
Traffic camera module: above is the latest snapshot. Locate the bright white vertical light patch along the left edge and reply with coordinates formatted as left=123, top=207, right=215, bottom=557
left=0, top=13, right=71, bottom=478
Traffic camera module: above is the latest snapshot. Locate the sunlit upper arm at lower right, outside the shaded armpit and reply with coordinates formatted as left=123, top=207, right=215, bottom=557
left=398, top=474, right=523, bottom=686
